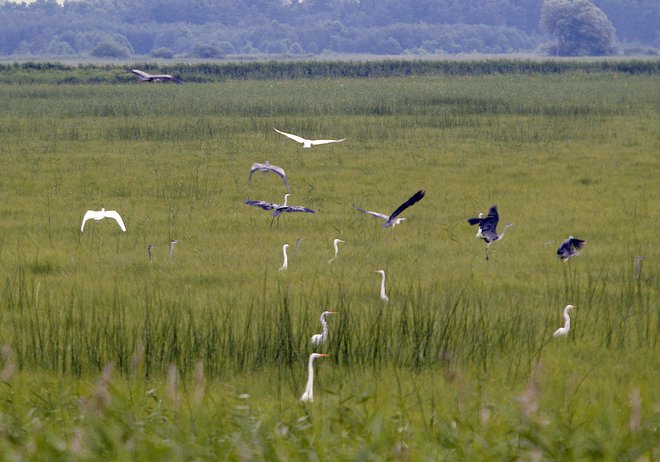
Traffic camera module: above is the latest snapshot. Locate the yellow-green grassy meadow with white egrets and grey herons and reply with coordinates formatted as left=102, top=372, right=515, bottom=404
left=0, top=72, right=660, bottom=461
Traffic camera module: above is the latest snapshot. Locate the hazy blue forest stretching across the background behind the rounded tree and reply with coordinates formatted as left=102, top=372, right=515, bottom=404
left=0, top=0, right=660, bottom=59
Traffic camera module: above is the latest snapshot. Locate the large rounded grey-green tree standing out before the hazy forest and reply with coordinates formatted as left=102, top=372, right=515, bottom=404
left=541, top=0, right=616, bottom=56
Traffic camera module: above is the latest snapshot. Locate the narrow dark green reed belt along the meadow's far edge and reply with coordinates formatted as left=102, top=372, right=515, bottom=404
left=0, top=59, right=660, bottom=84
